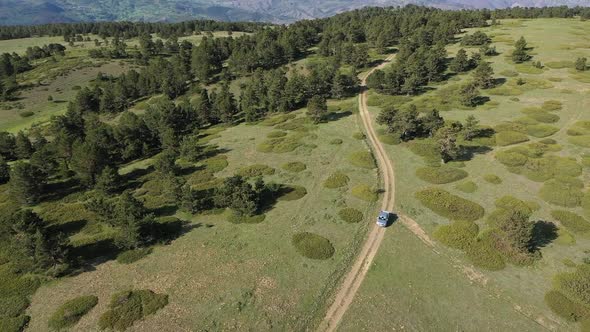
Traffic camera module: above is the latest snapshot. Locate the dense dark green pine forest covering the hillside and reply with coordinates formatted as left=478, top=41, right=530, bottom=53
left=0, top=6, right=588, bottom=332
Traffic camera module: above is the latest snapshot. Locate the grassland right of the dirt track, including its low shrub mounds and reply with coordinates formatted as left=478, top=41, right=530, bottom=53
left=342, top=19, right=590, bottom=331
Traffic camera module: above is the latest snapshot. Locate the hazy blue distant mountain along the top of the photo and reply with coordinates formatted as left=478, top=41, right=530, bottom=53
left=0, top=0, right=590, bottom=25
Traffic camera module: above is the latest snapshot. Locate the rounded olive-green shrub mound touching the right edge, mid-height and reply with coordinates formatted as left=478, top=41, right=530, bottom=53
left=539, top=177, right=584, bottom=208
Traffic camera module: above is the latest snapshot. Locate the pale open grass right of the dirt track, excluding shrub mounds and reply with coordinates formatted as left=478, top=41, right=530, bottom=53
left=341, top=19, right=590, bottom=331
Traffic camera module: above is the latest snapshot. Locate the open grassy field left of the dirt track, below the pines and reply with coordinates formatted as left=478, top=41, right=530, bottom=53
left=23, top=99, right=377, bottom=331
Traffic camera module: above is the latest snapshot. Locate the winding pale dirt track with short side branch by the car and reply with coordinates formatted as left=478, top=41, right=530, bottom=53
left=319, top=55, right=434, bottom=332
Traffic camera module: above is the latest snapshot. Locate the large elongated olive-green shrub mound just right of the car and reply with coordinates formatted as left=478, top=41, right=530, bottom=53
left=416, top=188, right=484, bottom=221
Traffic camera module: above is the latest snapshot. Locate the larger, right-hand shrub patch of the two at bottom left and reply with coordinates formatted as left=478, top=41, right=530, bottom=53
left=98, top=290, right=168, bottom=331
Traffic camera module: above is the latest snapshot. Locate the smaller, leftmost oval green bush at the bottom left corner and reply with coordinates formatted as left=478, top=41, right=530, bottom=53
left=48, top=295, right=98, bottom=330
